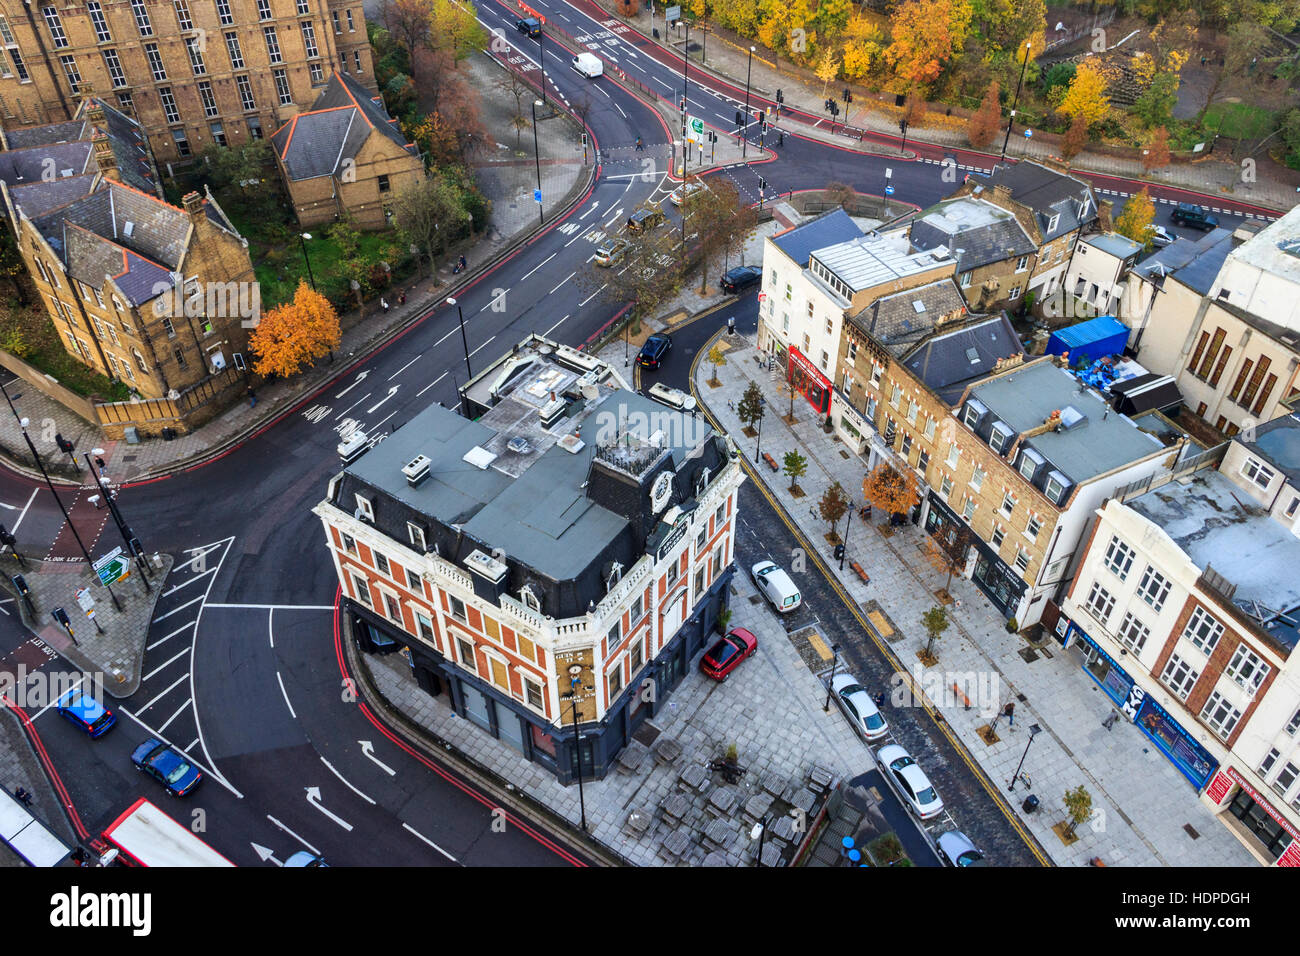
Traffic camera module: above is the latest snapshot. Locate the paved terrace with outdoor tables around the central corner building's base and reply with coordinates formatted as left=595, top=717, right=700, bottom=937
left=363, top=574, right=875, bottom=866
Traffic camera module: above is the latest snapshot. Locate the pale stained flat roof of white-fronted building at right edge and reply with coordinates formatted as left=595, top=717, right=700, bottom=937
left=1125, top=468, right=1300, bottom=648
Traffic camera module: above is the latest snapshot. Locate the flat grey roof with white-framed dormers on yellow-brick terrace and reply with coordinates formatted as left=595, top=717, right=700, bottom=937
left=971, top=362, right=1164, bottom=484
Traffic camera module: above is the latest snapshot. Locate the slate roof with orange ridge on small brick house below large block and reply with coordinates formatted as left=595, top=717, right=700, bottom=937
left=270, top=70, right=417, bottom=181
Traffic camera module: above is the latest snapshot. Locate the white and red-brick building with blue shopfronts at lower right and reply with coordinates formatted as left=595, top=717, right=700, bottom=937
left=1058, top=418, right=1300, bottom=866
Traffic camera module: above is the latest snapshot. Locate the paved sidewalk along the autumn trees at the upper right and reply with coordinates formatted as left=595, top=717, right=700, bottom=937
left=597, top=0, right=1300, bottom=211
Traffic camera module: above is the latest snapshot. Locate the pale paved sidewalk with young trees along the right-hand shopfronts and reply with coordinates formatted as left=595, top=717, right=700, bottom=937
left=693, top=327, right=1256, bottom=866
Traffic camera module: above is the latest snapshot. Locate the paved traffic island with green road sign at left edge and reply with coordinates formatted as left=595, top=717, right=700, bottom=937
left=0, top=549, right=174, bottom=698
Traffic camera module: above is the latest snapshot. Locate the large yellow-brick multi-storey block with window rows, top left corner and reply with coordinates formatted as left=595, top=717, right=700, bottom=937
left=0, top=0, right=374, bottom=163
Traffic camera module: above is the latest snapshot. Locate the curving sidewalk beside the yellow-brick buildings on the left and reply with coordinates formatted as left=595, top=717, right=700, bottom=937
left=0, top=49, right=595, bottom=483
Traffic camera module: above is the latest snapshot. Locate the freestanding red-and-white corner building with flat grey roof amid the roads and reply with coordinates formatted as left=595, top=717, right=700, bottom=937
left=313, top=336, right=744, bottom=782
